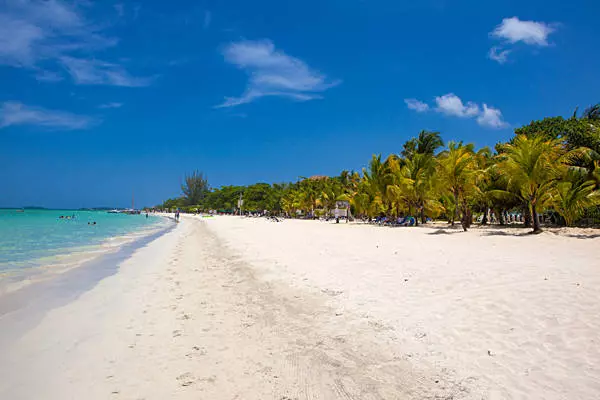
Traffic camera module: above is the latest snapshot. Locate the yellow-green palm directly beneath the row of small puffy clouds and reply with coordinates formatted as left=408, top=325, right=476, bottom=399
left=437, top=142, right=482, bottom=231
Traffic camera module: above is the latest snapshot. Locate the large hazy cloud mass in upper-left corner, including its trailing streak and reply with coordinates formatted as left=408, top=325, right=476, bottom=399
left=0, top=0, right=146, bottom=86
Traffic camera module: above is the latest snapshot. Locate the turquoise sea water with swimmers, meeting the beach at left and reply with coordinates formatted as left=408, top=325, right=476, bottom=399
left=0, top=209, right=170, bottom=273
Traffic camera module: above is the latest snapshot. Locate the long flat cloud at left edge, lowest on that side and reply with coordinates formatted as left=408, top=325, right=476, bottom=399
left=0, top=101, right=97, bottom=130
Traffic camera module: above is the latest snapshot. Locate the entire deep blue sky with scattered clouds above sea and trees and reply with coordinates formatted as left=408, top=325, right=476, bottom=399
left=0, top=0, right=600, bottom=208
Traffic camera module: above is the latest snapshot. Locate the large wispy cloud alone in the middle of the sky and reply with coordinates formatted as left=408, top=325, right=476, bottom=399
left=217, top=40, right=340, bottom=107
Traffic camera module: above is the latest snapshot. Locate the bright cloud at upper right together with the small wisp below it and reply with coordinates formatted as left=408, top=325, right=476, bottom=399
left=488, top=17, right=556, bottom=64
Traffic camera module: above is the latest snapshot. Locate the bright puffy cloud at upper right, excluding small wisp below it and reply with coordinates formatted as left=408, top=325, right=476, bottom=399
left=491, top=17, right=554, bottom=46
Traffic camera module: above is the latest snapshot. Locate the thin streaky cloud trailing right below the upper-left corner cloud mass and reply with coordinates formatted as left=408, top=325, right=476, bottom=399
left=60, top=57, right=152, bottom=87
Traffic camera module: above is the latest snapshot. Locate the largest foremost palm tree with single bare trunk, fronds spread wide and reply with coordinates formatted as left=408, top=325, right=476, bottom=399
left=498, top=134, right=571, bottom=233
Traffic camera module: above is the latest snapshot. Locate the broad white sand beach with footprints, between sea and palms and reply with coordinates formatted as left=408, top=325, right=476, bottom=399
left=0, top=216, right=600, bottom=400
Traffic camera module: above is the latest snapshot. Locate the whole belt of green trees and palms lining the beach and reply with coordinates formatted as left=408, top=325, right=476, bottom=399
left=159, top=105, right=600, bottom=233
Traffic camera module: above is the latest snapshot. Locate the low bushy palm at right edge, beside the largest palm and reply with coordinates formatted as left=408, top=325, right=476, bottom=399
left=550, top=169, right=600, bottom=226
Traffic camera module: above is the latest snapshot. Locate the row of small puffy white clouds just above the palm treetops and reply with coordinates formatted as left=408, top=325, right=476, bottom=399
left=404, top=93, right=509, bottom=129
